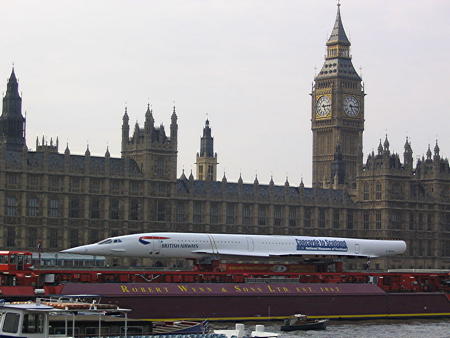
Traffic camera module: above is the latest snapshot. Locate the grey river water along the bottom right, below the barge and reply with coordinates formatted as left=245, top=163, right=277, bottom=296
left=211, top=319, right=450, bottom=338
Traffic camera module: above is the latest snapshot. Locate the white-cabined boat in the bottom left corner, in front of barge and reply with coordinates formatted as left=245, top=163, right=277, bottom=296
left=0, top=296, right=209, bottom=338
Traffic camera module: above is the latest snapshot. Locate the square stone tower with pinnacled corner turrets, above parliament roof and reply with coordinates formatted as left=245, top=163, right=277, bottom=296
left=122, top=105, right=178, bottom=181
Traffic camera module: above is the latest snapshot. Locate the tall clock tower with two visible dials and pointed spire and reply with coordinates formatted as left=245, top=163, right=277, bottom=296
left=311, top=4, right=364, bottom=187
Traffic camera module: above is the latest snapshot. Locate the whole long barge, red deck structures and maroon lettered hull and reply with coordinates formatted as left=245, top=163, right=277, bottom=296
left=0, top=252, right=450, bottom=321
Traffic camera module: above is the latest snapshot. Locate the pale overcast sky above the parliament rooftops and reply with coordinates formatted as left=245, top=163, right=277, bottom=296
left=0, top=0, right=450, bottom=186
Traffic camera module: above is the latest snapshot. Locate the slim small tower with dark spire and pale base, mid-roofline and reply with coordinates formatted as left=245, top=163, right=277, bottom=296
left=195, top=119, right=217, bottom=181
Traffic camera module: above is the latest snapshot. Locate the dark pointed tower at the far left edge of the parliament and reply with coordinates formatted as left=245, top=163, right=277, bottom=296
left=0, top=68, right=26, bottom=151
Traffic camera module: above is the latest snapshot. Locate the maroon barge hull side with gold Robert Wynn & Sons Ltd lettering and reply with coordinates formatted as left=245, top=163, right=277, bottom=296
left=62, top=283, right=450, bottom=321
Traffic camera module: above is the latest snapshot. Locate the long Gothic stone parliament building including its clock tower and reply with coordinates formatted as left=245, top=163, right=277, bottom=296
left=0, top=6, right=450, bottom=270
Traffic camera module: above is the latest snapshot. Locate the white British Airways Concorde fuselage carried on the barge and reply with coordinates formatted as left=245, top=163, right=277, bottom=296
left=62, top=232, right=406, bottom=259
